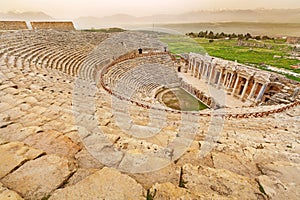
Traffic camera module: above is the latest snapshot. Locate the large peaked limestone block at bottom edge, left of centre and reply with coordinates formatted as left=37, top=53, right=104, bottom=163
left=49, top=167, right=145, bottom=200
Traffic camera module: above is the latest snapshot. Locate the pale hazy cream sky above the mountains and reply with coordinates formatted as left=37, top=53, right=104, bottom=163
left=0, top=0, right=300, bottom=18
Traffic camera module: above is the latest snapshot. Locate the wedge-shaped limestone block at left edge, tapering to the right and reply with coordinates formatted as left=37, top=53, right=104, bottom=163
left=0, top=142, right=44, bottom=178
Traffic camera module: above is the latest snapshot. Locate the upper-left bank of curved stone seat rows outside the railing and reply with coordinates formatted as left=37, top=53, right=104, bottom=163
left=0, top=30, right=166, bottom=84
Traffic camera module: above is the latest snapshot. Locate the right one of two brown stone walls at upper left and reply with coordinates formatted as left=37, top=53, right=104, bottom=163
left=30, top=22, right=75, bottom=31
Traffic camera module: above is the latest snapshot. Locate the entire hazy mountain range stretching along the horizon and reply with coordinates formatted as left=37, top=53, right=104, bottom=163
left=0, top=8, right=300, bottom=29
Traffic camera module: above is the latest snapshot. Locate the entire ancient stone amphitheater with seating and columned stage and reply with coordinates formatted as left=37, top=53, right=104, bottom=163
left=0, top=22, right=300, bottom=200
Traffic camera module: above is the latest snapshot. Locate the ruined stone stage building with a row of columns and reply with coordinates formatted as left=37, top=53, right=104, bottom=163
left=185, top=53, right=297, bottom=105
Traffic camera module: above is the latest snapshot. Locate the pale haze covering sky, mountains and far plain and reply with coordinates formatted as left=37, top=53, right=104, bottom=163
left=0, top=0, right=300, bottom=36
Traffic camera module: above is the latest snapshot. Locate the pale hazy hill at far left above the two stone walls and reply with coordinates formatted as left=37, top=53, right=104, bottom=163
left=0, top=11, right=54, bottom=21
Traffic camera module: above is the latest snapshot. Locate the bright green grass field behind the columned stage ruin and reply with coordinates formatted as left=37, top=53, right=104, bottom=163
left=160, top=35, right=300, bottom=82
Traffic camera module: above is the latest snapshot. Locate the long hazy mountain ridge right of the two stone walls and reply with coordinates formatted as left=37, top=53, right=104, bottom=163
left=74, top=8, right=300, bottom=28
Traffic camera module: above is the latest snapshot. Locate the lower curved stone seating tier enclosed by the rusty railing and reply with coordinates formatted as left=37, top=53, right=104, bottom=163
left=103, top=55, right=179, bottom=100
